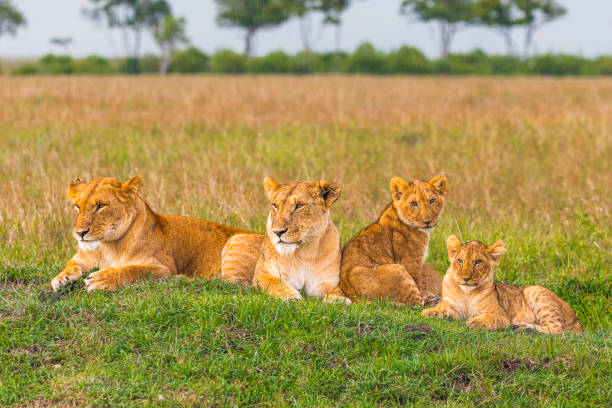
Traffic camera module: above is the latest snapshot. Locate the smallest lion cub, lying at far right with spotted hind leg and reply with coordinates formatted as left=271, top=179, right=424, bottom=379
left=422, top=235, right=582, bottom=333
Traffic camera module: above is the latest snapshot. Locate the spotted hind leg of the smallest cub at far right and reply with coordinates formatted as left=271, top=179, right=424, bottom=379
left=516, top=285, right=582, bottom=334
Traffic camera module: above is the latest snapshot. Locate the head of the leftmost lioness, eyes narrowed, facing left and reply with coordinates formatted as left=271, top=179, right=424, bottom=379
left=68, top=176, right=142, bottom=251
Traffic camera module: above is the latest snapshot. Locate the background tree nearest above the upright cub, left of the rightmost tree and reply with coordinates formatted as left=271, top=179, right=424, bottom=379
left=401, top=0, right=476, bottom=57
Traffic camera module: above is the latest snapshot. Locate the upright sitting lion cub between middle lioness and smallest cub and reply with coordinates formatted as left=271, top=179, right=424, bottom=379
left=340, top=176, right=447, bottom=305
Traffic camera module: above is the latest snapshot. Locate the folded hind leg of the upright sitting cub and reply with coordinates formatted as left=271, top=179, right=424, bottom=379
left=348, top=264, right=423, bottom=306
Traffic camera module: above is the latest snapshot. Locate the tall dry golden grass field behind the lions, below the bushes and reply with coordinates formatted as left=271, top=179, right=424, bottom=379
left=0, top=76, right=612, bottom=260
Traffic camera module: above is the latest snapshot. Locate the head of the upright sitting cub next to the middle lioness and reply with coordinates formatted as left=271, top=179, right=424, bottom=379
left=390, top=175, right=447, bottom=231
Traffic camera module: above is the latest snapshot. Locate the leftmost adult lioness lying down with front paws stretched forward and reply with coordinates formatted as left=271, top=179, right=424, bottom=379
left=51, top=176, right=245, bottom=291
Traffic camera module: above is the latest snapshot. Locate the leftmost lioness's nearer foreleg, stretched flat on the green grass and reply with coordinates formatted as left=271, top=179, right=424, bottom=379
left=85, top=265, right=170, bottom=291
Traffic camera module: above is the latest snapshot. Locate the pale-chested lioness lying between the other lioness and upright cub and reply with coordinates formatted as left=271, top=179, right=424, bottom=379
left=221, top=177, right=350, bottom=304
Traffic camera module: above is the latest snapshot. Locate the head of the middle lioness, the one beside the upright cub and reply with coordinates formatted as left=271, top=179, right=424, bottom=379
left=264, top=177, right=340, bottom=255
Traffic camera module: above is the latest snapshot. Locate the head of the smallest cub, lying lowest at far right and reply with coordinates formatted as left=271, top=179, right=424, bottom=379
left=446, top=235, right=506, bottom=292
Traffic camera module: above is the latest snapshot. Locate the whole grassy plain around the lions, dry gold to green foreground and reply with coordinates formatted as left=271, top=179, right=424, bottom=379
left=0, top=76, right=612, bottom=407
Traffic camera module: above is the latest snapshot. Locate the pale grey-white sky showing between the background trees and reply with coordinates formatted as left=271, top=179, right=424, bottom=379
left=0, top=0, right=612, bottom=57
